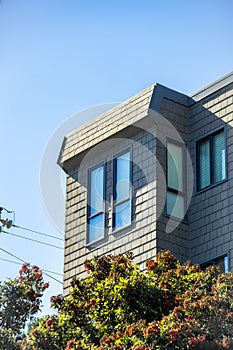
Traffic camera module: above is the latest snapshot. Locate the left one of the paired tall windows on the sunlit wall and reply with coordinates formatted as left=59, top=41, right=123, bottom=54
left=87, top=165, right=105, bottom=243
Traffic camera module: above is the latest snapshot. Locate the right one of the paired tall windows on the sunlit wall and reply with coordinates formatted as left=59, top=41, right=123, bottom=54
left=113, top=152, right=131, bottom=229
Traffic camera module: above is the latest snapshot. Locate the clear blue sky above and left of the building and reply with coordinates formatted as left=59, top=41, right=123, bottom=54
left=0, top=0, right=233, bottom=312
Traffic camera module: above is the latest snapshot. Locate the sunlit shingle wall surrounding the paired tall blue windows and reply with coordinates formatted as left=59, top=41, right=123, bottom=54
left=64, top=124, right=157, bottom=294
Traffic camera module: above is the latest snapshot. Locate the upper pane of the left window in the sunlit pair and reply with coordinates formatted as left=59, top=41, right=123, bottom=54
left=89, top=166, right=104, bottom=215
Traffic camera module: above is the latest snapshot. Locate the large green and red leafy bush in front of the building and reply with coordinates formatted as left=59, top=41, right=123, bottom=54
left=22, top=251, right=233, bottom=350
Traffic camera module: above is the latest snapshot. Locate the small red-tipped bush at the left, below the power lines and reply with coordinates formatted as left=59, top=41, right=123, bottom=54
left=0, top=264, right=49, bottom=350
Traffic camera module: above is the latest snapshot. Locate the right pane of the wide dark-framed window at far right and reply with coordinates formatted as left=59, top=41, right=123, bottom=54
left=213, top=132, right=226, bottom=183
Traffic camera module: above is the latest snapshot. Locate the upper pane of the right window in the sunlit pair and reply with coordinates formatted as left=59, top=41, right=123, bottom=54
left=115, top=152, right=130, bottom=202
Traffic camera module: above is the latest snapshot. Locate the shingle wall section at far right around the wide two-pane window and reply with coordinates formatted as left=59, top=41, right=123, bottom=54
left=189, top=85, right=233, bottom=268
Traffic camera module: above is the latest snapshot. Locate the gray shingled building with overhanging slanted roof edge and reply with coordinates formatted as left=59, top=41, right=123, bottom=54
left=58, top=72, right=233, bottom=293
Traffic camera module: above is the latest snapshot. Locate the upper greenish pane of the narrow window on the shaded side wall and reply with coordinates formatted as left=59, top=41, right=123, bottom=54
left=167, top=142, right=183, bottom=191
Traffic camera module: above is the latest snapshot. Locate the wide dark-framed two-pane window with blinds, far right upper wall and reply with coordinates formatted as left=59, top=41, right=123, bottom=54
left=197, top=130, right=226, bottom=191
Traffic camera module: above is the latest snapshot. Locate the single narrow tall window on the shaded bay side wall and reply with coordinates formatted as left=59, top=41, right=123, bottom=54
left=166, top=142, right=185, bottom=219
